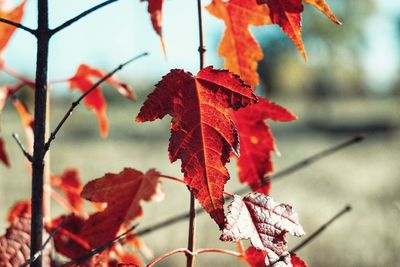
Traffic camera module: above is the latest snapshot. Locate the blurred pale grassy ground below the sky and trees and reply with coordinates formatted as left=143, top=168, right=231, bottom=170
left=0, top=97, right=400, bottom=267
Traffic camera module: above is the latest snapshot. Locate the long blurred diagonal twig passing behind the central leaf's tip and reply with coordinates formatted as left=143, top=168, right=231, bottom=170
left=129, top=136, right=364, bottom=239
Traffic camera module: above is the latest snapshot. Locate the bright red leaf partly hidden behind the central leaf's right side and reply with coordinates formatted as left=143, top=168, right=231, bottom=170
left=231, top=97, right=296, bottom=194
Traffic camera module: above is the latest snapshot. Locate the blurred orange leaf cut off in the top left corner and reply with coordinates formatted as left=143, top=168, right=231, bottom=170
left=0, top=0, right=26, bottom=52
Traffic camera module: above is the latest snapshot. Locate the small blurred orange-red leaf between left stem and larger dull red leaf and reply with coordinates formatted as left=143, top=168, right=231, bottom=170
left=51, top=169, right=83, bottom=214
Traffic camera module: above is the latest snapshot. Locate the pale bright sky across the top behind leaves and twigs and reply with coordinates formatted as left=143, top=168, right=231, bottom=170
left=5, top=0, right=400, bottom=92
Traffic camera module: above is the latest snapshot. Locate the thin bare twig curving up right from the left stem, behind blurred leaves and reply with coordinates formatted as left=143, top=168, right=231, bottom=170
left=45, top=52, right=148, bottom=153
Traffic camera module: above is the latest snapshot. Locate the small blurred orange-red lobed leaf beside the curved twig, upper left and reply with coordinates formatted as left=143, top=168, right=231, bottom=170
left=68, top=64, right=136, bottom=137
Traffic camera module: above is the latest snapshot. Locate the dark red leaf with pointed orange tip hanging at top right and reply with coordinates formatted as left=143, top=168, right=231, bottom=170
left=257, top=0, right=307, bottom=59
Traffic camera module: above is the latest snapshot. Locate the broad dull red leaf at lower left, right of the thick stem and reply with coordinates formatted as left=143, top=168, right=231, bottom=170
left=81, top=168, right=163, bottom=247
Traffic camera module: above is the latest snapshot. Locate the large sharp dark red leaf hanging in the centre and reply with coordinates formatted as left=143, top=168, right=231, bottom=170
left=136, top=67, right=257, bottom=226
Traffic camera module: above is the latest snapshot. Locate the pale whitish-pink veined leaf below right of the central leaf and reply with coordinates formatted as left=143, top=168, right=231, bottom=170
left=220, top=193, right=304, bottom=267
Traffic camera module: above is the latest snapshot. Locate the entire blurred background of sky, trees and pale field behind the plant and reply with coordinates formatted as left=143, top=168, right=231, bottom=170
left=0, top=0, right=400, bottom=267
